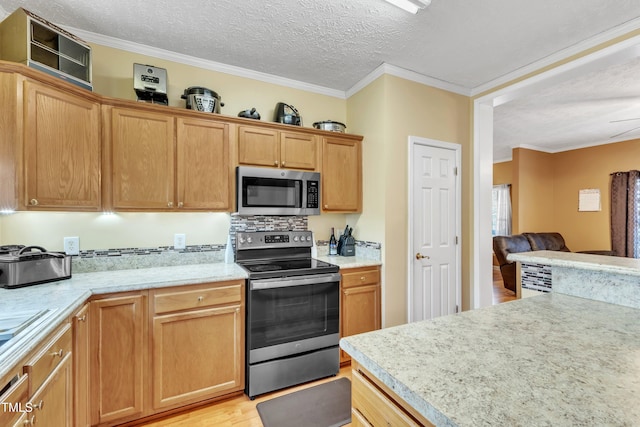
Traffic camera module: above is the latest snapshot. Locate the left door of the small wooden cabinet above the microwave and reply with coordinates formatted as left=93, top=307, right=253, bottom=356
left=238, top=126, right=280, bottom=168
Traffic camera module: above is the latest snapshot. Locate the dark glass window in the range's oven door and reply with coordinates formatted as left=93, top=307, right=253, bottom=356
left=249, top=282, right=340, bottom=350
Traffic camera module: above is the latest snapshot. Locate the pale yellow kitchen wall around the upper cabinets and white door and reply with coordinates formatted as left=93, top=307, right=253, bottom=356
left=0, top=45, right=473, bottom=326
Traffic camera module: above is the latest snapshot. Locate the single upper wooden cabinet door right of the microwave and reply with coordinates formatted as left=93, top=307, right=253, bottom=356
left=321, top=136, right=362, bottom=213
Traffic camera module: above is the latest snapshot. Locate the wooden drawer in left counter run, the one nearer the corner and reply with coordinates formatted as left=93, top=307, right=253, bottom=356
left=24, top=324, right=72, bottom=396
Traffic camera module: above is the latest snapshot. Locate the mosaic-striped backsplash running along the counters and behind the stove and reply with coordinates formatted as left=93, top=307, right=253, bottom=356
left=72, top=214, right=382, bottom=273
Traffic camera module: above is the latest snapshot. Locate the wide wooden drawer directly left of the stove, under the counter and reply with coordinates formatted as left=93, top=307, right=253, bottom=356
left=154, top=282, right=242, bottom=314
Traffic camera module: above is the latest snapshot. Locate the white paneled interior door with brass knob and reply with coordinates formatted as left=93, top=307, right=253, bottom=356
left=408, top=137, right=461, bottom=322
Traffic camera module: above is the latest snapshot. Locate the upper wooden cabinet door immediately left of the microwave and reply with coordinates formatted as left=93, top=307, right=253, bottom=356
left=176, top=118, right=232, bottom=211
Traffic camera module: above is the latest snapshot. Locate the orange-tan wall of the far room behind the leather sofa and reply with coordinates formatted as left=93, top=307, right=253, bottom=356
left=493, top=139, right=640, bottom=251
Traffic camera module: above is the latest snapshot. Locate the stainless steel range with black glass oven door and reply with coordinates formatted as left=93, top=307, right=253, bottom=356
left=236, top=231, right=340, bottom=399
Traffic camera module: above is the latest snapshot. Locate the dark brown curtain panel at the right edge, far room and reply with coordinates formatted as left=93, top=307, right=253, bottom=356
left=611, top=170, right=640, bottom=258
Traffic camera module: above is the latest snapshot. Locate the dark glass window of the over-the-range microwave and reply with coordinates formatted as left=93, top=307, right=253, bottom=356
left=242, top=177, right=302, bottom=208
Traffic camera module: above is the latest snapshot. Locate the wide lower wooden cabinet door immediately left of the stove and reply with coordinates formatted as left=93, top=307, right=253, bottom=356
left=152, top=305, right=244, bottom=410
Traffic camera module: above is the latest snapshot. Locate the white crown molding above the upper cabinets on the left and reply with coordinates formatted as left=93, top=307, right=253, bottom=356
left=66, top=27, right=346, bottom=99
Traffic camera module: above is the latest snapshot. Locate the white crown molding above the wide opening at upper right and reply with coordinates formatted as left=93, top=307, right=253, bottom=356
left=470, top=18, right=640, bottom=97
